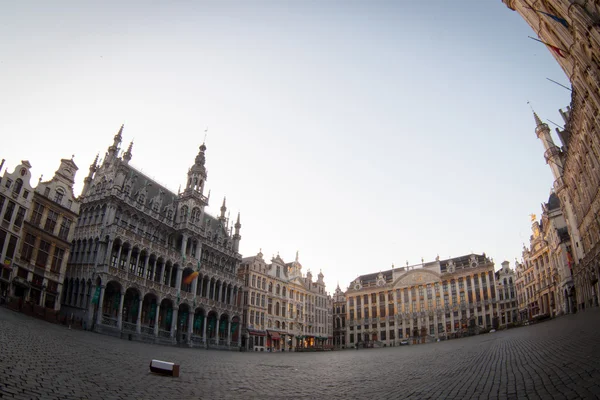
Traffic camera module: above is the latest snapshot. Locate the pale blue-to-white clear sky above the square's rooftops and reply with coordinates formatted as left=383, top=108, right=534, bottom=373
left=0, top=0, right=570, bottom=292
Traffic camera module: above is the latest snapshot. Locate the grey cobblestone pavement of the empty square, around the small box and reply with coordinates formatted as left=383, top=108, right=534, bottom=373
left=0, top=308, right=600, bottom=399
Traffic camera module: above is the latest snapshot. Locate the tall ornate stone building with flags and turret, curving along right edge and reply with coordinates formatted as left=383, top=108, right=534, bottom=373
left=503, top=0, right=600, bottom=310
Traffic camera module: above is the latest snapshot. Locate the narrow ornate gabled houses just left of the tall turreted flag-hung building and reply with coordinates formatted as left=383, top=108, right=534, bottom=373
left=516, top=192, right=576, bottom=321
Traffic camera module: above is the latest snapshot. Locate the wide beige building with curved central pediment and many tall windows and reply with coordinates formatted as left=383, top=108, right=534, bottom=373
left=345, top=254, right=498, bottom=347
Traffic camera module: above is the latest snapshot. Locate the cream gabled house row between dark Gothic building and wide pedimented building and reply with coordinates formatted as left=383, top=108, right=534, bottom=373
left=239, top=251, right=333, bottom=351
